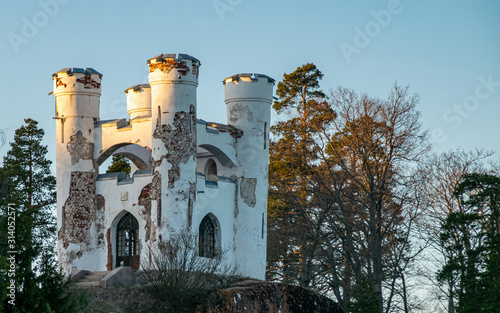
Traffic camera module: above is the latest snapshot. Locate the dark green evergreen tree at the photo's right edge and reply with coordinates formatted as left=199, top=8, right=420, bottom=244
left=438, top=173, right=500, bottom=312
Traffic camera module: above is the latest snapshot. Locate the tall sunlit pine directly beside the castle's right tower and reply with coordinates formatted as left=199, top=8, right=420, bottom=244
left=268, top=63, right=335, bottom=287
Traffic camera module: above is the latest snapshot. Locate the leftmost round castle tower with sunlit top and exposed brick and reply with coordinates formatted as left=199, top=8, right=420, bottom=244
left=53, top=68, right=102, bottom=273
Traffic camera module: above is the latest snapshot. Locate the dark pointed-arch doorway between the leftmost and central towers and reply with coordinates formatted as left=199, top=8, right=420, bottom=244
left=116, top=213, right=140, bottom=270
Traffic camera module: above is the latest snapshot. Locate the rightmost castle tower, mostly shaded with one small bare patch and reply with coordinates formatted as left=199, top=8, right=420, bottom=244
left=223, top=74, right=274, bottom=279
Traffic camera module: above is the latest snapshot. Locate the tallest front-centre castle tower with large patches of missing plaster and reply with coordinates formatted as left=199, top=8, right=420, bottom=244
left=148, top=54, right=200, bottom=240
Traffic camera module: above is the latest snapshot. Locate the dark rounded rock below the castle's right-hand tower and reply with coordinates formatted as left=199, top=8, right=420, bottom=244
left=205, top=280, right=343, bottom=313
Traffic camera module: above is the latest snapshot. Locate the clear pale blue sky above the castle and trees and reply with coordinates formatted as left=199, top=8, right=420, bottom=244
left=0, top=0, right=500, bottom=167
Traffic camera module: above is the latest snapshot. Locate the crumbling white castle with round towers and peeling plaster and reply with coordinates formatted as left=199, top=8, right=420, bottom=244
left=53, top=54, right=274, bottom=279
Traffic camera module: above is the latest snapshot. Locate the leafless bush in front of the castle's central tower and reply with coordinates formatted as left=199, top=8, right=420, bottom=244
left=141, top=231, right=236, bottom=312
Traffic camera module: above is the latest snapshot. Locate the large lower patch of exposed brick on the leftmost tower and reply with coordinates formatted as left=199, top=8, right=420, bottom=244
left=62, top=171, right=96, bottom=248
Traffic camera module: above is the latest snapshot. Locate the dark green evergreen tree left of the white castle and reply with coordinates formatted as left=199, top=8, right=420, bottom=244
left=0, top=119, right=86, bottom=312
